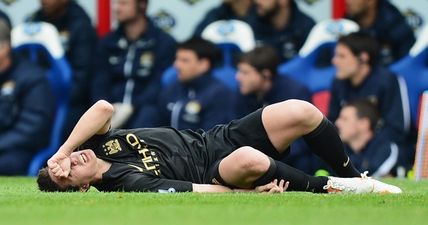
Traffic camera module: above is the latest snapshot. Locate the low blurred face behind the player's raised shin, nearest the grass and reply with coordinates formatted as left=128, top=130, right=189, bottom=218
left=336, top=106, right=361, bottom=143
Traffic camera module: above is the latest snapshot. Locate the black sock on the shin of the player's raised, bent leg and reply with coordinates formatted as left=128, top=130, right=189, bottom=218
left=303, top=117, right=360, bottom=177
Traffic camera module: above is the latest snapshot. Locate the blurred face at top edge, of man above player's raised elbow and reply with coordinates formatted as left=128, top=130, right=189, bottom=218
left=113, top=0, right=138, bottom=23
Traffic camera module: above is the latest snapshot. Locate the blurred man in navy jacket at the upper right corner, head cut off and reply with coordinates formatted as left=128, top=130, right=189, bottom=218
left=345, top=0, right=416, bottom=65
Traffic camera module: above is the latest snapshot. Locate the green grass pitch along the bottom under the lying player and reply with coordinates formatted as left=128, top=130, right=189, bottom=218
left=0, top=177, right=428, bottom=225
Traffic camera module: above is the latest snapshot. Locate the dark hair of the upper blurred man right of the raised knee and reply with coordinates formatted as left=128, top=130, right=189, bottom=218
left=337, top=31, right=378, bottom=67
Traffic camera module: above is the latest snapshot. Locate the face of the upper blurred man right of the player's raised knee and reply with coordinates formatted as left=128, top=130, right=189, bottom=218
left=332, top=43, right=361, bottom=80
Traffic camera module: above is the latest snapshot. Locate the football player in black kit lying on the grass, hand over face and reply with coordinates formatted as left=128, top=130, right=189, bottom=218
left=37, top=100, right=401, bottom=193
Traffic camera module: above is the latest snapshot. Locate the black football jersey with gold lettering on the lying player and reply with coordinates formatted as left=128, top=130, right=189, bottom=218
left=80, top=127, right=216, bottom=192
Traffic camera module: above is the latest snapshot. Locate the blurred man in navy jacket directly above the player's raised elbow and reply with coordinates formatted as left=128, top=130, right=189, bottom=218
left=92, top=0, right=176, bottom=128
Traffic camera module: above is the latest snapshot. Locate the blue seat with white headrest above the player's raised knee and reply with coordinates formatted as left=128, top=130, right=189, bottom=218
left=278, top=19, right=359, bottom=113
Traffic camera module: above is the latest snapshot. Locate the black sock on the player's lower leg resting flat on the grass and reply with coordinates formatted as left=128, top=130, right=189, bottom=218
left=254, top=158, right=328, bottom=193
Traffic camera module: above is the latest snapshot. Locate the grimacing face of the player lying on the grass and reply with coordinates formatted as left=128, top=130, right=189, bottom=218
left=49, top=150, right=97, bottom=190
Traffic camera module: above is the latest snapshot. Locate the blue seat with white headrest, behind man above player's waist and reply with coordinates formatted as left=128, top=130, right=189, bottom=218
left=162, top=20, right=255, bottom=90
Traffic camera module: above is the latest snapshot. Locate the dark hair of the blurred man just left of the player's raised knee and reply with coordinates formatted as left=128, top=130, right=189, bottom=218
left=239, top=46, right=281, bottom=77
